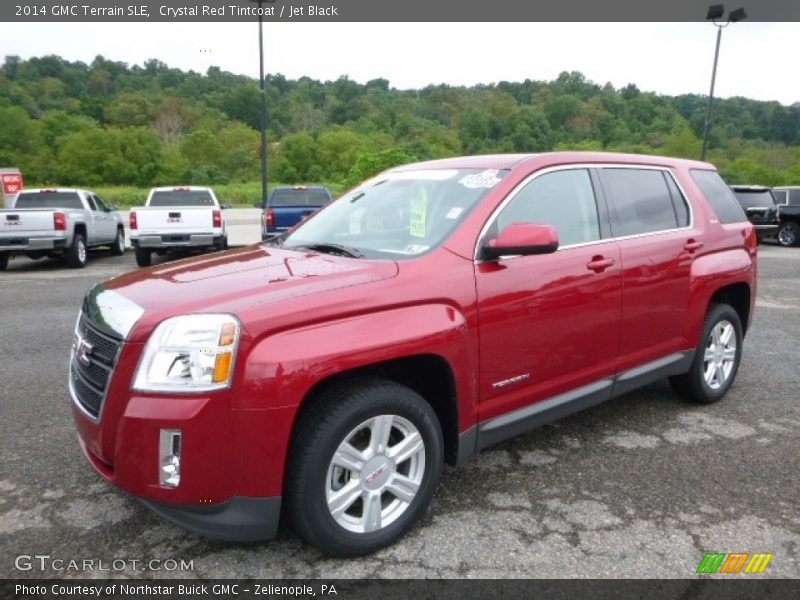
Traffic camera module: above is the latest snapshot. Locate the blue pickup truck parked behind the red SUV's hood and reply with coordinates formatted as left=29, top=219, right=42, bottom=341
left=261, top=185, right=332, bottom=240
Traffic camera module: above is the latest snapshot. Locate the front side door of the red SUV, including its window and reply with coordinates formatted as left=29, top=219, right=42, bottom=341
left=475, top=167, right=621, bottom=420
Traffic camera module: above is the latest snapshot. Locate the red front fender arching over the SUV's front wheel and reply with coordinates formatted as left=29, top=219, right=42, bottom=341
left=237, top=303, right=478, bottom=431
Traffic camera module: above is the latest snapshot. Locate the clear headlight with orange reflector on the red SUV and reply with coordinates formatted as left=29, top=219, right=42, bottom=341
left=133, top=314, right=240, bottom=392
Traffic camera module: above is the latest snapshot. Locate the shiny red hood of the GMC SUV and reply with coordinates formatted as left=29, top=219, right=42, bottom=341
left=83, top=245, right=398, bottom=342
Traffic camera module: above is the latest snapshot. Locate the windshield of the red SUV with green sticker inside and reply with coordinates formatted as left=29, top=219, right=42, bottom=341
left=275, top=169, right=506, bottom=258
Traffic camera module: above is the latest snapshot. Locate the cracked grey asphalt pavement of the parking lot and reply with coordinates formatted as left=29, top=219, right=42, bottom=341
left=0, top=241, right=800, bottom=578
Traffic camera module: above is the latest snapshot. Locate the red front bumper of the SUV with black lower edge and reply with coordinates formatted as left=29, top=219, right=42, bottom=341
left=72, top=376, right=297, bottom=542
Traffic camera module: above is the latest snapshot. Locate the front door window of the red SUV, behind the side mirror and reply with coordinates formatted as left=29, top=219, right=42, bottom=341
left=492, top=169, right=600, bottom=246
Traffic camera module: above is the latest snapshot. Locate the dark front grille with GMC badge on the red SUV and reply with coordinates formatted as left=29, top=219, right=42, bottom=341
left=70, top=313, right=122, bottom=418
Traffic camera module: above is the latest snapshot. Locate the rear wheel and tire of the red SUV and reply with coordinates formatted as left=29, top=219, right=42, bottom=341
left=669, top=304, right=743, bottom=404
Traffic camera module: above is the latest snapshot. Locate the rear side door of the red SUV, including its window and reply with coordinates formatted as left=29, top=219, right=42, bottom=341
left=597, top=166, right=702, bottom=371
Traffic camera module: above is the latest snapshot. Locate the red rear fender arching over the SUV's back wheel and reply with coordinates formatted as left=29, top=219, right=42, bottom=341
left=684, top=248, right=755, bottom=346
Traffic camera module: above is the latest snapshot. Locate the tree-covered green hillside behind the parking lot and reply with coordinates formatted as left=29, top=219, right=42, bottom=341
left=0, top=56, right=800, bottom=199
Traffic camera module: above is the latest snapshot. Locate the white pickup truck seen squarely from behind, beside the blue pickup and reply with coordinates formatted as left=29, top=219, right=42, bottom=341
left=130, top=186, right=228, bottom=267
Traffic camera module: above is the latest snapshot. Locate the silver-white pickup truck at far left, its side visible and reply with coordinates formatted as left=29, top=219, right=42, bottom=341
left=0, top=188, right=125, bottom=271
